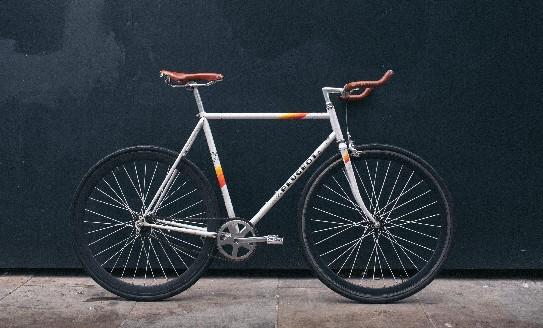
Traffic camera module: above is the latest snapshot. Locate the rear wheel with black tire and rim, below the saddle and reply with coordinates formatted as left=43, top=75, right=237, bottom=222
left=72, top=146, right=219, bottom=301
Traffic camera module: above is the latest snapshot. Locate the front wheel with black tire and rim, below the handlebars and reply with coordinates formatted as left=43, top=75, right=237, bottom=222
left=299, top=145, right=454, bottom=303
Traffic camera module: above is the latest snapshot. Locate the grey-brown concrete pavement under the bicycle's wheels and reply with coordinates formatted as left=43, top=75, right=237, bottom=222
left=0, top=273, right=543, bottom=328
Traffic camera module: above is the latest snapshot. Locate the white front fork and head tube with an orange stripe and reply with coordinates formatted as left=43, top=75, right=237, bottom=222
left=326, top=101, right=379, bottom=226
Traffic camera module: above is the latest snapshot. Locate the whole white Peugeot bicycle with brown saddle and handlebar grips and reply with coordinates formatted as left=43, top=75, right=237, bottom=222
left=71, top=70, right=453, bottom=303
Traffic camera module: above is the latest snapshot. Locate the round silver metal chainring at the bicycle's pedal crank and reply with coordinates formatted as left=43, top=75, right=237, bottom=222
left=217, top=219, right=256, bottom=261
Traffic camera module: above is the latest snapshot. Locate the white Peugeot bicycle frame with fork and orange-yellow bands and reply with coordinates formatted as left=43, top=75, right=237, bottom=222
left=142, top=83, right=378, bottom=238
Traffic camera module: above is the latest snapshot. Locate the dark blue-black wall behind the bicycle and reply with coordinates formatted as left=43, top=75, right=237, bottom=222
left=0, top=0, right=543, bottom=268
